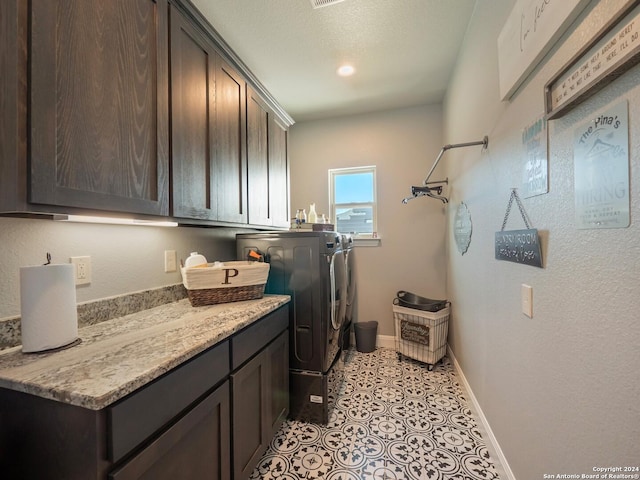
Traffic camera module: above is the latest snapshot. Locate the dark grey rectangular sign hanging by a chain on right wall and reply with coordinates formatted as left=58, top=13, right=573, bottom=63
left=495, top=188, right=542, bottom=268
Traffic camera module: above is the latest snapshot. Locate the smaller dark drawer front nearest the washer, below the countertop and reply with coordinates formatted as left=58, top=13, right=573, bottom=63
left=231, top=305, right=289, bottom=370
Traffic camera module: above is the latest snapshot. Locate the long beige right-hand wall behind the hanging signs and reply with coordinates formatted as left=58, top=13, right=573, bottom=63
left=444, top=0, right=640, bottom=480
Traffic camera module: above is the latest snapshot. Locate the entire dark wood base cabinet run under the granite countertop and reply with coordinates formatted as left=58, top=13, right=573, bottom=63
left=0, top=306, right=289, bottom=480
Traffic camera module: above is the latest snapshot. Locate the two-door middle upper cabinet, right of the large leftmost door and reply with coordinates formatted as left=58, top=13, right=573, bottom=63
left=170, top=2, right=247, bottom=224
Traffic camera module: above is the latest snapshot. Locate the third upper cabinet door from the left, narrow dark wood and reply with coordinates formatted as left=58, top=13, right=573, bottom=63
left=213, top=56, right=247, bottom=223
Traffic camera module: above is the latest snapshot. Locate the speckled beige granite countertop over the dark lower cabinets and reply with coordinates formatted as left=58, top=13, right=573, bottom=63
left=0, top=295, right=290, bottom=410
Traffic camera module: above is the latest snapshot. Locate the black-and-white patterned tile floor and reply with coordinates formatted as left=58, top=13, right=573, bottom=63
left=250, top=348, right=499, bottom=480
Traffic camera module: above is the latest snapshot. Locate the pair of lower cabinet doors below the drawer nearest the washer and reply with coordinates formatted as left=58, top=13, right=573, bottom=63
left=231, top=330, right=289, bottom=480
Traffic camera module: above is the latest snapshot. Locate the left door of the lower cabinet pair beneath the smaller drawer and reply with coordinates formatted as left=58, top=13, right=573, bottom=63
left=231, top=349, right=271, bottom=480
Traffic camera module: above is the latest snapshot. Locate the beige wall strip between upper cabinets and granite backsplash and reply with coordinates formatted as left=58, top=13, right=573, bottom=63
left=0, top=218, right=245, bottom=318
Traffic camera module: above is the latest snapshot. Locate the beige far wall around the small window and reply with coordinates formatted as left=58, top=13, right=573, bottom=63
left=289, top=105, right=446, bottom=335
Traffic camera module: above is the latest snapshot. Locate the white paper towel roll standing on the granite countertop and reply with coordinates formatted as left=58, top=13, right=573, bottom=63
left=20, top=263, right=78, bottom=352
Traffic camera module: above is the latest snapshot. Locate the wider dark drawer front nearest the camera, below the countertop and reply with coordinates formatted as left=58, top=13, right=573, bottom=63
left=107, top=341, right=229, bottom=462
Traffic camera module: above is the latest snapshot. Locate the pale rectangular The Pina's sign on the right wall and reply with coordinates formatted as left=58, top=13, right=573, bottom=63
left=573, top=100, right=630, bottom=229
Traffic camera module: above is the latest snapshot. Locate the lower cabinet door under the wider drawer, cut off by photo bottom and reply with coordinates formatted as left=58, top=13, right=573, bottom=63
left=109, top=382, right=231, bottom=480
